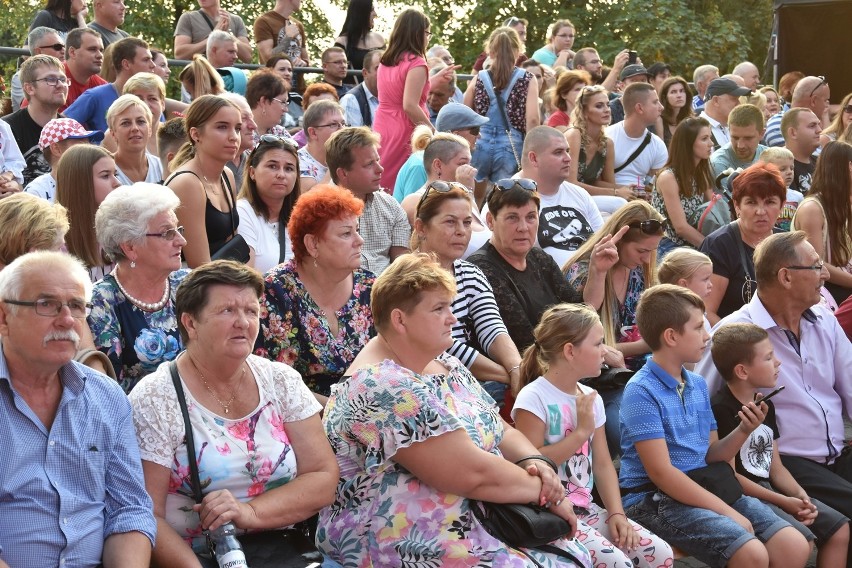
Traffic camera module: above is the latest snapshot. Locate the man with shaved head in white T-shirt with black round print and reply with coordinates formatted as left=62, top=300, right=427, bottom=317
left=514, top=126, right=603, bottom=266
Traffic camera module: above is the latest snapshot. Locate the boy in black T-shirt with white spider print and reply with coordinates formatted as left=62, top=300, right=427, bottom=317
left=711, top=323, right=849, bottom=566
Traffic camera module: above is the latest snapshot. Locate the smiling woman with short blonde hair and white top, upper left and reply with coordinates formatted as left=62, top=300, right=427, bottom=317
left=106, top=95, right=163, bottom=185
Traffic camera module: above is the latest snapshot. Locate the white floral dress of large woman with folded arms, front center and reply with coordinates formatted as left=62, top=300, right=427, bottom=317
left=317, top=355, right=591, bottom=567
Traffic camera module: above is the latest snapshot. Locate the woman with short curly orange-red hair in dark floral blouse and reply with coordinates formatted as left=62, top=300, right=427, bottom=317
left=255, top=185, right=375, bottom=396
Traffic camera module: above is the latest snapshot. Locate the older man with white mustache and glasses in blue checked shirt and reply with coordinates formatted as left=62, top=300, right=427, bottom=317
left=0, top=252, right=157, bottom=568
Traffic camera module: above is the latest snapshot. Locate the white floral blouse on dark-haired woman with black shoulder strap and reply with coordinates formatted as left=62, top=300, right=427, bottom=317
left=130, top=355, right=322, bottom=551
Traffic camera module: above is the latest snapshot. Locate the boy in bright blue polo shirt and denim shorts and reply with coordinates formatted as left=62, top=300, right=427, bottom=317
left=619, top=284, right=810, bottom=568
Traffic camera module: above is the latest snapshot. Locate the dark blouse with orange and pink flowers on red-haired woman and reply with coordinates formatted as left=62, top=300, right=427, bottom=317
left=255, top=260, right=376, bottom=396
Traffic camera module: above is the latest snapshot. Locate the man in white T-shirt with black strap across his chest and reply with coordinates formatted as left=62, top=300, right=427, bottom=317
left=606, top=83, right=668, bottom=186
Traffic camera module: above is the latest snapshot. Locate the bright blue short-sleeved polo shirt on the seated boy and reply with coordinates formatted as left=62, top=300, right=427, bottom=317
left=618, top=359, right=716, bottom=507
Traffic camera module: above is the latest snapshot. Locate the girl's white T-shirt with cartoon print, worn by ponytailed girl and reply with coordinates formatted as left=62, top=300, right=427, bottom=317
left=512, top=377, right=606, bottom=509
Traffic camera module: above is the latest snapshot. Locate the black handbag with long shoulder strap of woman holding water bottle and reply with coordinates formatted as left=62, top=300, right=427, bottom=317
left=169, top=361, right=323, bottom=568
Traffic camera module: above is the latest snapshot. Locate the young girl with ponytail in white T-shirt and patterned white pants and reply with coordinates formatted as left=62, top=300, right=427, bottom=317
left=512, top=304, right=673, bottom=568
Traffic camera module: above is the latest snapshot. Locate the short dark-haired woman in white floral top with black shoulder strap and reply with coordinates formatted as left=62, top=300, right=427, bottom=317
left=130, top=260, right=338, bottom=566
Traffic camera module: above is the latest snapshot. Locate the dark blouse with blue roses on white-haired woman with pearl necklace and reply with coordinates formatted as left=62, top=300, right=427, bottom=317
left=88, top=269, right=189, bottom=393
